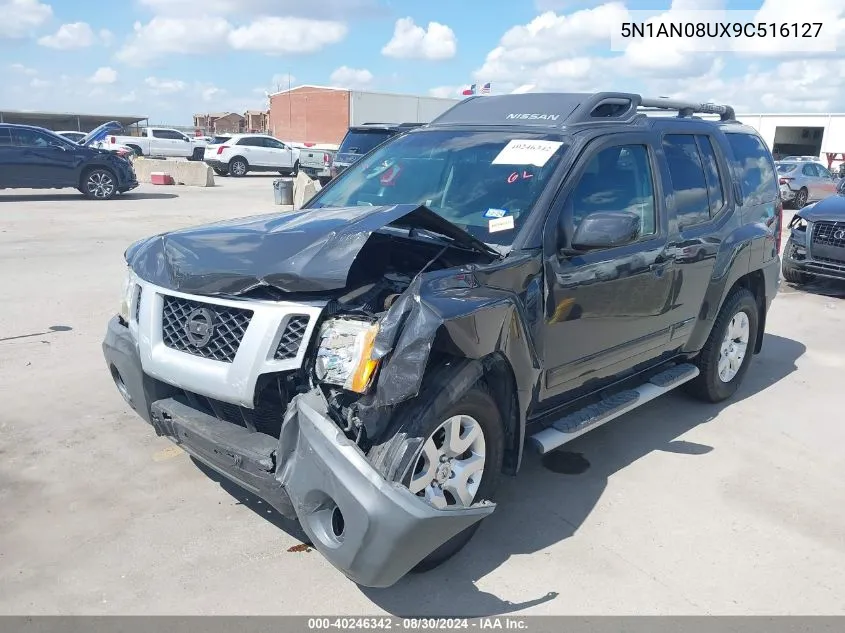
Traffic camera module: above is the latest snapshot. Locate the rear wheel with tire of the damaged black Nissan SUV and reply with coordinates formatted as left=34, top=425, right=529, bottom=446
left=687, top=288, right=760, bottom=403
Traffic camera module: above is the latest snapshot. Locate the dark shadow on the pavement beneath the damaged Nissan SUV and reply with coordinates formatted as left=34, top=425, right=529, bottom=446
left=196, top=334, right=806, bottom=617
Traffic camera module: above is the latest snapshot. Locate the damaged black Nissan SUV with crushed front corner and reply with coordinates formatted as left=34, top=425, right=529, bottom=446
left=103, top=93, right=782, bottom=587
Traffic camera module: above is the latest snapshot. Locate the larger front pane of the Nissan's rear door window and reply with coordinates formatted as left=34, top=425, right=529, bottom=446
left=663, top=134, right=710, bottom=229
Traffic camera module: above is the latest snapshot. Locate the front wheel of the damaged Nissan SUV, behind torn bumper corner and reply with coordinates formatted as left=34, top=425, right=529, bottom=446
left=369, top=379, right=504, bottom=572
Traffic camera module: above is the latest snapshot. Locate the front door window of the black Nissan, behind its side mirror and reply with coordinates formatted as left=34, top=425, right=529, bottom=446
left=567, top=145, right=657, bottom=235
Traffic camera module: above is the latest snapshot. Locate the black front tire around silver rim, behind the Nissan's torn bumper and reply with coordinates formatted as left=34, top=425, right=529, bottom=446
left=368, top=372, right=504, bottom=573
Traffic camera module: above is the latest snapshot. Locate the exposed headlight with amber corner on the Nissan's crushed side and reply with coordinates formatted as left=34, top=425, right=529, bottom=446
left=314, top=319, right=378, bottom=393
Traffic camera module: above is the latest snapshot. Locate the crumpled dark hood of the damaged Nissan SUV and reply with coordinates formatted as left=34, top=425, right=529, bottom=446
left=125, top=204, right=493, bottom=295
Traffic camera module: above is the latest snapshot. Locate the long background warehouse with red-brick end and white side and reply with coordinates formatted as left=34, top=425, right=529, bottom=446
left=269, top=86, right=459, bottom=145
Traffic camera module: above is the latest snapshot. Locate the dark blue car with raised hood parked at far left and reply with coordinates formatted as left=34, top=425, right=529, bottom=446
left=0, top=123, right=138, bottom=200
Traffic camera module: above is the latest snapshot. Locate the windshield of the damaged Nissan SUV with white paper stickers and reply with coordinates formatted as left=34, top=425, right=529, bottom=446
left=313, top=130, right=566, bottom=246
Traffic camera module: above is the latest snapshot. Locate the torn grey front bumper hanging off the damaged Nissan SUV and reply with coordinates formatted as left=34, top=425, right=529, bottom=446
left=103, top=319, right=495, bottom=587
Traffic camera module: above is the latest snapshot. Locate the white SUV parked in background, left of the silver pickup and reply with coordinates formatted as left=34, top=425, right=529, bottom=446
left=203, top=134, right=299, bottom=176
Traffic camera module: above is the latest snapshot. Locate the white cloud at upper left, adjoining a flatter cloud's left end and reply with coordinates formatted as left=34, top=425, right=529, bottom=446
left=117, top=16, right=231, bottom=66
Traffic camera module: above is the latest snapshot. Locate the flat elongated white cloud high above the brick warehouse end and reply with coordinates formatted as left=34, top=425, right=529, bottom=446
left=229, top=17, right=347, bottom=55
